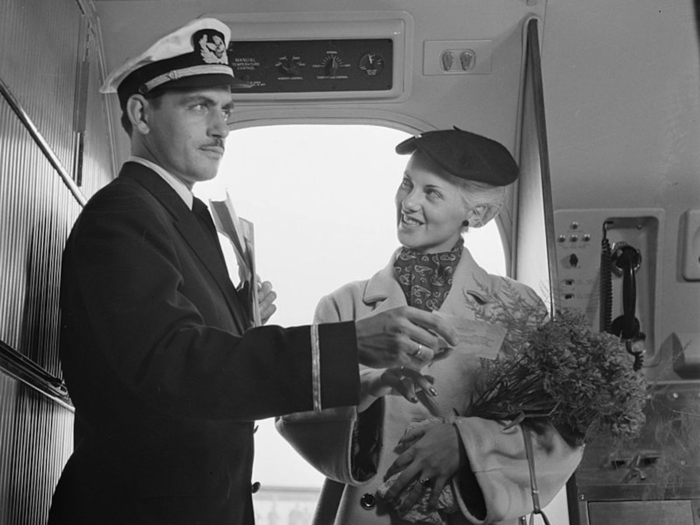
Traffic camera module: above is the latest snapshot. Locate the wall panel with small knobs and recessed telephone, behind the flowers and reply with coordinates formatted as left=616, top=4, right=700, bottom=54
left=554, top=209, right=664, bottom=363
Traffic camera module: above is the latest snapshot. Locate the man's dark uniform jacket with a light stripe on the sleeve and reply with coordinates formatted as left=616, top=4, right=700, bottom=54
left=49, top=162, right=359, bottom=525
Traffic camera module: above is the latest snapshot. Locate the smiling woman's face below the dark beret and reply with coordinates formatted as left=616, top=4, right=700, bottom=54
left=396, top=153, right=467, bottom=253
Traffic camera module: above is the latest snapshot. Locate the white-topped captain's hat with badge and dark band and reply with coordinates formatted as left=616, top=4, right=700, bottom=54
left=100, top=18, right=247, bottom=109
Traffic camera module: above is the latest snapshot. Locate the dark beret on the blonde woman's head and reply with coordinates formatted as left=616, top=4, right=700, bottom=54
left=396, top=126, right=519, bottom=186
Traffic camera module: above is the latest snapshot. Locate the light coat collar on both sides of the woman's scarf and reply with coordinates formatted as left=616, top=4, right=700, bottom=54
left=363, top=248, right=498, bottom=311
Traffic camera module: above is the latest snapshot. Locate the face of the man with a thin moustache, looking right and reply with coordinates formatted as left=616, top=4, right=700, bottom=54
left=143, top=86, right=233, bottom=189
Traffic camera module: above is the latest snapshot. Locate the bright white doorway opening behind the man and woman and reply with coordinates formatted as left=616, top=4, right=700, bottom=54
left=195, top=125, right=506, bottom=525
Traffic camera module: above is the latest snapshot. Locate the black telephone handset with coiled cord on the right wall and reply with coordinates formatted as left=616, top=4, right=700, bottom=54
left=600, top=222, right=646, bottom=370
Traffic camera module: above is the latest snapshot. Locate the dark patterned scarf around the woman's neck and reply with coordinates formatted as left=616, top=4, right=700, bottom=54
left=394, top=237, right=464, bottom=311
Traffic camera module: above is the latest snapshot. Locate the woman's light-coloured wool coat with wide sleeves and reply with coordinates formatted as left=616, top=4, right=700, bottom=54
left=277, top=249, right=582, bottom=525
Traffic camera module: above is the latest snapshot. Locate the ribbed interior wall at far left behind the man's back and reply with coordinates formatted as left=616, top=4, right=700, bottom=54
left=0, top=0, right=112, bottom=525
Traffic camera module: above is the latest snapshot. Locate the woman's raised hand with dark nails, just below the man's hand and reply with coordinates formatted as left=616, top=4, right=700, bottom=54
left=358, top=366, right=437, bottom=412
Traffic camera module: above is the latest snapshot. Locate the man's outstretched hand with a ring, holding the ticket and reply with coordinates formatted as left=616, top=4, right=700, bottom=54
left=355, top=306, right=457, bottom=369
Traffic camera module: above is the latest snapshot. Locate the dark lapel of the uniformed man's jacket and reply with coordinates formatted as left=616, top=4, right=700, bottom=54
left=119, top=162, right=249, bottom=333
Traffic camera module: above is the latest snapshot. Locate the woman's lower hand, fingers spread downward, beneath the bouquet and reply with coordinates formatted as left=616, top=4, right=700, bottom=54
left=385, top=422, right=467, bottom=515
